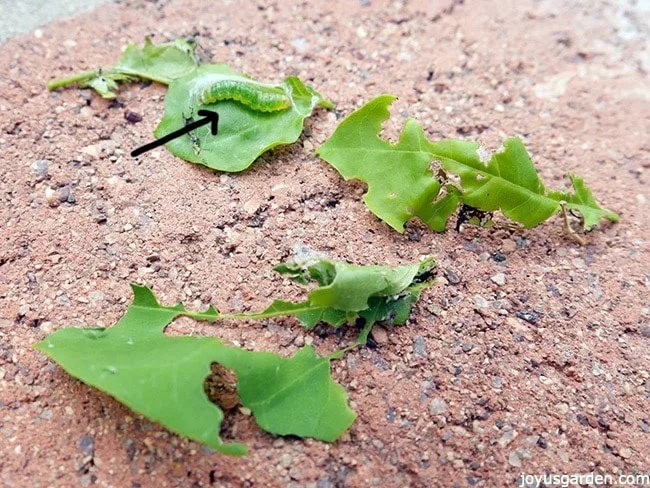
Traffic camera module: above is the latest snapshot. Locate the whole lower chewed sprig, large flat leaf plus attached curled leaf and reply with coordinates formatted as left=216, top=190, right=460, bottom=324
left=35, top=257, right=433, bottom=455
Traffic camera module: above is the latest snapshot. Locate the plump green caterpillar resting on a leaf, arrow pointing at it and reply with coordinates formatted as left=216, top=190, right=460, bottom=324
left=198, top=75, right=292, bottom=112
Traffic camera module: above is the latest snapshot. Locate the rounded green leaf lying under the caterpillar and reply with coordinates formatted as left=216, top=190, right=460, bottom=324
left=154, top=64, right=332, bottom=172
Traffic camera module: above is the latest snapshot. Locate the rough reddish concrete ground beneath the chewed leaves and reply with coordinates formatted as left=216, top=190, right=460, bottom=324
left=0, top=0, right=650, bottom=488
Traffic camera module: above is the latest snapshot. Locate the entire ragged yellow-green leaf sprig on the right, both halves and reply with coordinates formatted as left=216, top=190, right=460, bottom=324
left=317, top=95, right=618, bottom=232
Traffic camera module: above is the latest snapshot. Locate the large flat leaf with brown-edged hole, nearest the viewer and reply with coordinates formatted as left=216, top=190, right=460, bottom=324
left=35, top=286, right=355, bottom=455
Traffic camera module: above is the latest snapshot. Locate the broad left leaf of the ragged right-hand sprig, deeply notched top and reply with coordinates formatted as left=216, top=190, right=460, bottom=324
left=317, top=95, right=440, bottom=232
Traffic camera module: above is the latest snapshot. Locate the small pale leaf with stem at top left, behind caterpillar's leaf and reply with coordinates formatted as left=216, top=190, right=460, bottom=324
left=47, top=37, right=198, bottom=98
